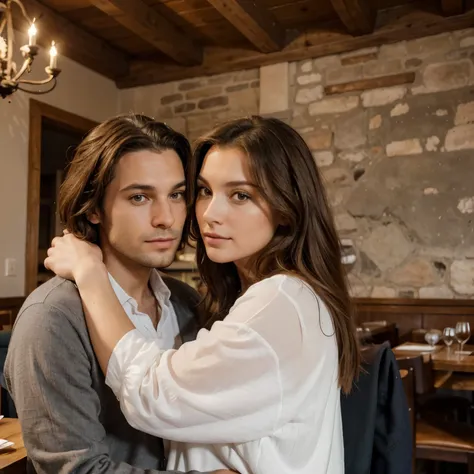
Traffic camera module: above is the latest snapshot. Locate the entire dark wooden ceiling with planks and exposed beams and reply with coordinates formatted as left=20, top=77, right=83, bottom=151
left=16, top=0, right=474, bottom=88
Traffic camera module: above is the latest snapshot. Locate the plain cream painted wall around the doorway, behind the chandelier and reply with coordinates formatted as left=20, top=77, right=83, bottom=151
left=0, top=32, right=119, bottom=298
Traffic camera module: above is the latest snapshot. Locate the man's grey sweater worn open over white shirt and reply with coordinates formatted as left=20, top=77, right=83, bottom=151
left=5, top=277, right=207, bottom=474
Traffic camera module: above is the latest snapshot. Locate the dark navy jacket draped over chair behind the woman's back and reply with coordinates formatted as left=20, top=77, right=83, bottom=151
left=341, top=344, right=413, bottom=474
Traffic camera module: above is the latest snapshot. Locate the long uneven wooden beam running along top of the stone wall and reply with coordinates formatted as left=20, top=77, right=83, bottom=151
left=117, top=5, right=474, bottom=88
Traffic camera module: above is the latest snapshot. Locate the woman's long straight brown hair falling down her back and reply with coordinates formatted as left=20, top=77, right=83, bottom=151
left=189, top=117, right=360, bottom=393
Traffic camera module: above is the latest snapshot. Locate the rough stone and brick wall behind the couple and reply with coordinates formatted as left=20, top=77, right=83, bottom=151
left=122, top=29, right=474, bottom=298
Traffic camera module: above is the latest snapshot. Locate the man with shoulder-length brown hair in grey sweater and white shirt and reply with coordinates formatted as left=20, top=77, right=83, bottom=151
left=5, top=115, right=230, bottom=474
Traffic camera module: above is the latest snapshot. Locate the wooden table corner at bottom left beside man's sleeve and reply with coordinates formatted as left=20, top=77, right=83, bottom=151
left=0, top=418, right=26, bottom=474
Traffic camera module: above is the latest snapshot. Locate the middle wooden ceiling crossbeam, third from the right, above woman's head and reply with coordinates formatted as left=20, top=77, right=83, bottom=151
left=207, top=0, right=285, bottom=53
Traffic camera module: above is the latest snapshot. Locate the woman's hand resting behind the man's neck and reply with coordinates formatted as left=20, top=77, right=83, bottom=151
left=44, top=231, right=105, bottom=282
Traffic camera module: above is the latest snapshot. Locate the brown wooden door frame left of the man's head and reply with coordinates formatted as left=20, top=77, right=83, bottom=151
left=25, top=99, right=97, bottom=295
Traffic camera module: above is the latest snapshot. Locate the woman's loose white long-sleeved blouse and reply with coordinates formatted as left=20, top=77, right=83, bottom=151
left=106, top=275, right=344, bottom=474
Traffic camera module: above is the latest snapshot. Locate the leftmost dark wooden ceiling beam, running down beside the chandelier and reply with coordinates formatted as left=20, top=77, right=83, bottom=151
left=18, top=0, right=129, bottom=79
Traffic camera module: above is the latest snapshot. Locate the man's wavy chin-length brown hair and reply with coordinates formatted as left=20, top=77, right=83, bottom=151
left=59, top=114, right=191, bottom=248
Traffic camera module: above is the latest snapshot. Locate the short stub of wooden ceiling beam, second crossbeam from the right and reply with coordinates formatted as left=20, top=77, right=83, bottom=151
left=331, top=0, right=377, bottom=36
